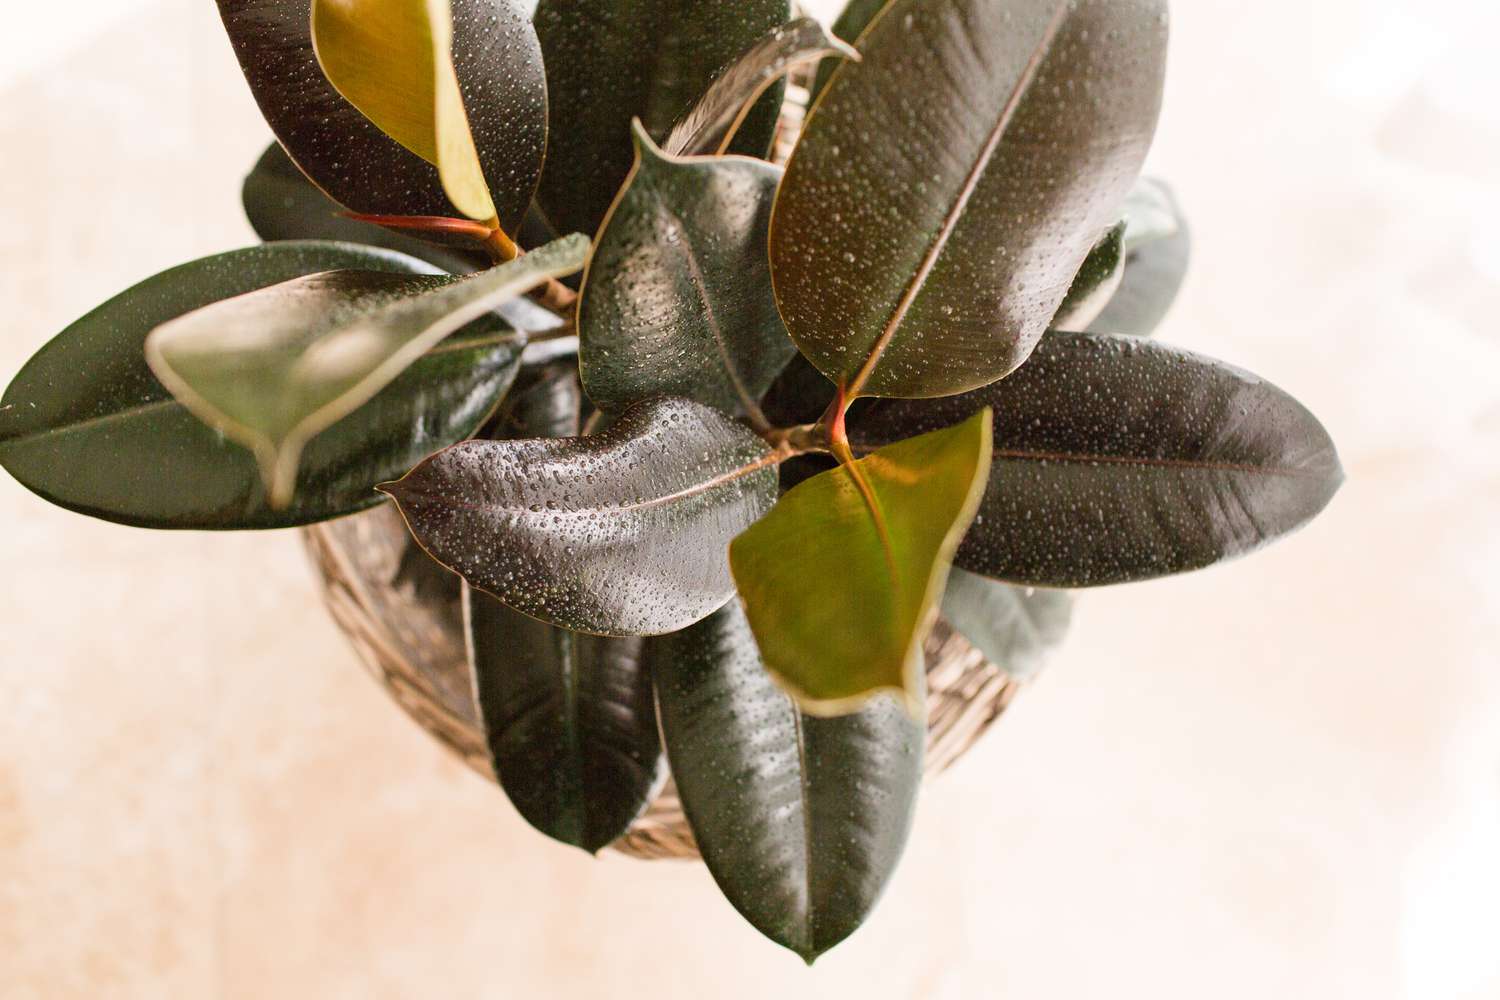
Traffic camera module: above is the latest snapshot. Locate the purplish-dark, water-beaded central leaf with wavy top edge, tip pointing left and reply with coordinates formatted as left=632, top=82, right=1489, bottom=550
left=381, top=399, right=777, bottom=636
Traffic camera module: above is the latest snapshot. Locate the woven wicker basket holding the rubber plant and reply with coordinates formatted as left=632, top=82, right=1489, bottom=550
left=303, top=504, right=1017, bottom=858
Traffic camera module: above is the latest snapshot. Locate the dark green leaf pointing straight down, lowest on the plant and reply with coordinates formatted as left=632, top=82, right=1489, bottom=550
left=647, top=603, right=924, bottom=961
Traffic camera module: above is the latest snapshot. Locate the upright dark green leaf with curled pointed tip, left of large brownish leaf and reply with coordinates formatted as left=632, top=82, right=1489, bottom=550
left=578, top=121, right=797, bottom=424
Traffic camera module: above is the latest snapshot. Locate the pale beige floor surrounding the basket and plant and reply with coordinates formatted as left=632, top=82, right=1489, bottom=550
left=0, top=0, right=1500, bottom=1000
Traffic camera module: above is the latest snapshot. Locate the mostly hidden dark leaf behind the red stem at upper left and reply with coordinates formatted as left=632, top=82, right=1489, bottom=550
left=240, top=142, right=492, bottom=274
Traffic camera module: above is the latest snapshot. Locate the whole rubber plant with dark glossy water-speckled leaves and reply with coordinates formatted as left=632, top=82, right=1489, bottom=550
left=0, top=0, right=1343, bottom=961
